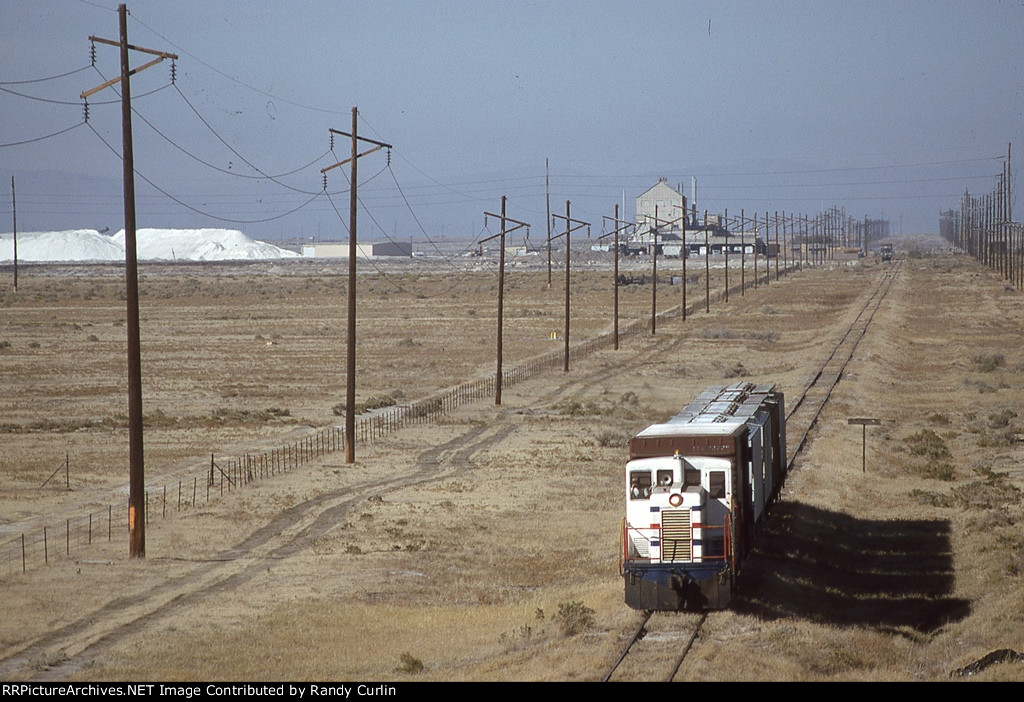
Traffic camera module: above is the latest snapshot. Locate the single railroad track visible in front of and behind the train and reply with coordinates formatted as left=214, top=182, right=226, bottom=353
left=602, top=260, right=902, bottom=683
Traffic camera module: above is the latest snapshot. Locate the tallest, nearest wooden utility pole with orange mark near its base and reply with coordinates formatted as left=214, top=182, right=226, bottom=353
left=81, top=4, right=177, bottom=558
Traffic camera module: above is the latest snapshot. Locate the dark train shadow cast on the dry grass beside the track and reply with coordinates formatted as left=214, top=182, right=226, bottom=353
left=733, top=501, right=970, bottom=633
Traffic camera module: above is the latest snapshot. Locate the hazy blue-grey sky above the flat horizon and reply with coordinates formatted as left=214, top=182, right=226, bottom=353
left=0, top=0, right=1024, bottom=240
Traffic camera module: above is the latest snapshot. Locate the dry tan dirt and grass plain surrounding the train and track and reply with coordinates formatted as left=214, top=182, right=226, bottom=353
left=0, top=242, right=1024, bottom=681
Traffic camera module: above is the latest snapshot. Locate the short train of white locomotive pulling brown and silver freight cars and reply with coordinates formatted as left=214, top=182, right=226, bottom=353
left=621, top=383, right=786, bottom=611
